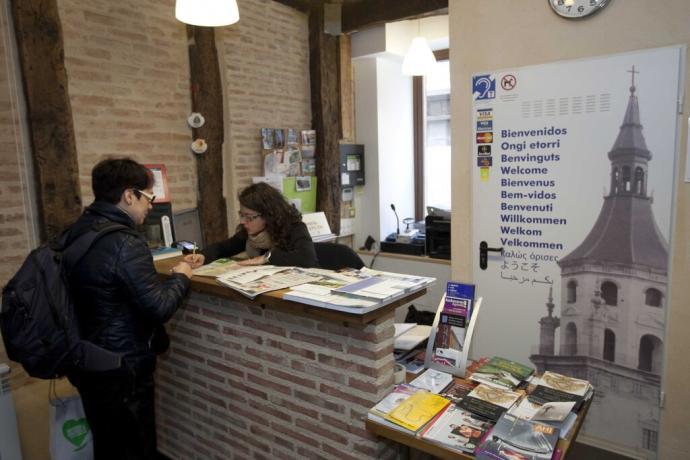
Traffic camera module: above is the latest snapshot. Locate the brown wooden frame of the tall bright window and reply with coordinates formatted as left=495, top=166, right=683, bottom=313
left=412, top=48, right=452, bottom=221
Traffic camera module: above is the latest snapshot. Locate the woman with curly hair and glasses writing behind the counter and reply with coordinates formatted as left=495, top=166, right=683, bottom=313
left=184, top=183, right=319, bottom=268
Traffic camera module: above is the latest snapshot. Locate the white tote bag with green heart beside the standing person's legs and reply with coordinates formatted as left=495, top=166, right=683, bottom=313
left=50, top=396, right=93, bottom=460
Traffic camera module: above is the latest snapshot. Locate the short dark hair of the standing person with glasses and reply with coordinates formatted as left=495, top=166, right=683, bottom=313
left=91, top=158, right=153, bottom=203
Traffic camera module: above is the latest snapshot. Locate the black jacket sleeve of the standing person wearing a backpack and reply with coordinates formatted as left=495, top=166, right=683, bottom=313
left=117, top=236, right=191, bottom=324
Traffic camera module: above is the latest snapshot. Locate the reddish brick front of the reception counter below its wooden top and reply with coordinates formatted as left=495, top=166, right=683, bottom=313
left=156, top=264, right=420, bottom=460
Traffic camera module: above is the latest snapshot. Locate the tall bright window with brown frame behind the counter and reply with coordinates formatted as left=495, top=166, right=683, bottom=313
left=413, top=50, right=451, bottom=220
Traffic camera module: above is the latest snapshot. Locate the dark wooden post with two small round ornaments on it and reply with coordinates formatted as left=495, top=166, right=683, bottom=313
left=187, top=25, right=228, bottom=245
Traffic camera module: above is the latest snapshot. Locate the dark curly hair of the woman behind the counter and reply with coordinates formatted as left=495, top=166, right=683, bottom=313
left=237, top=182, right=302, bottom=248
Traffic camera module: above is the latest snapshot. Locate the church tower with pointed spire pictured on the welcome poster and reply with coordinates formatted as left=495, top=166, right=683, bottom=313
left=530, top=66, right=669, bottom=458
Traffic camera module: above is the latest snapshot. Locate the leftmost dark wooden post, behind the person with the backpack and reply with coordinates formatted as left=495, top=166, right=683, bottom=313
left=12, top=0, right=82, bottom=241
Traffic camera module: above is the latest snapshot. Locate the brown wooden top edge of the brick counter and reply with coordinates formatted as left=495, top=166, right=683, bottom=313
left=154, top=257, right=426, bottom=324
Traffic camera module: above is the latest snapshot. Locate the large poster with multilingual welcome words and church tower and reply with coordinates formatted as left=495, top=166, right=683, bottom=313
left=471, top=47, right=682, bottom=458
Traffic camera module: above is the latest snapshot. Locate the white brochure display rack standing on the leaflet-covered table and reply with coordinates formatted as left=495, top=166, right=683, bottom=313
left=424, top=294, right=482, bottom=377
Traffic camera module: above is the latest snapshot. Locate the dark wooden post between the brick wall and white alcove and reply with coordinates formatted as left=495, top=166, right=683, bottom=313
left=309, top=6, right=341, bottom=235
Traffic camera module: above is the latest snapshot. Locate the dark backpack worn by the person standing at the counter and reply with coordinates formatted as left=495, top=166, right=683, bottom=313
left=0, top=221, right=133, bottom=379
